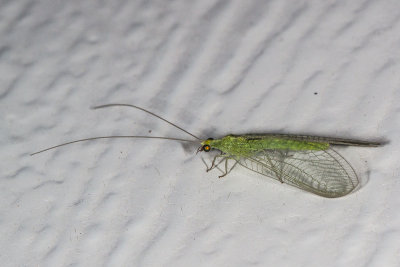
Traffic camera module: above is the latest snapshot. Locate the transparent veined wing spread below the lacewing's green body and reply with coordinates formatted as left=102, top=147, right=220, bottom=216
left=238, top=148, right=359, bottom=198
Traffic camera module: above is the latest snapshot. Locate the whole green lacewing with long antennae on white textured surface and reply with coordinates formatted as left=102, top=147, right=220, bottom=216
left=31, top=104, right=384, bottom=198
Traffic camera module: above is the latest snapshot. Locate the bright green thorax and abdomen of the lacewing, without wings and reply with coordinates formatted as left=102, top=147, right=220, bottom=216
left=202, top=135, right=329, bottom=156
